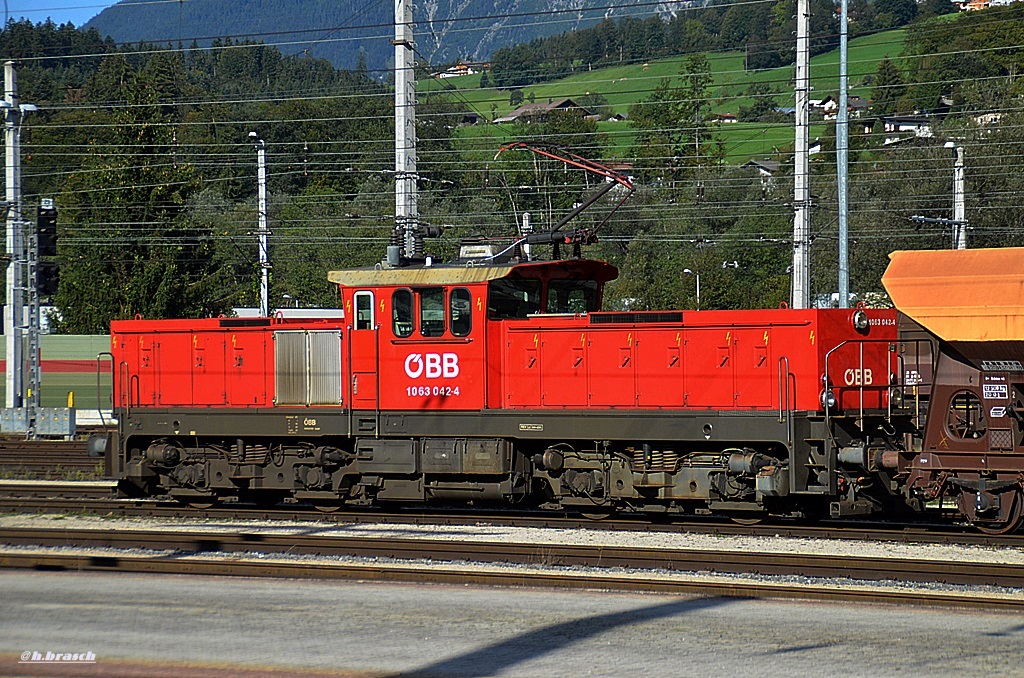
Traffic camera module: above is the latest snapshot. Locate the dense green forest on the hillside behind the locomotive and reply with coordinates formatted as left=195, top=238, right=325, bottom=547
left=6, top=3, right=1024, bottom=333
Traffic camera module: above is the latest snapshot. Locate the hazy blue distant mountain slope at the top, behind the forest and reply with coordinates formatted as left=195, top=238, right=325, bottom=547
left=85, top=0, right=690, bottom=69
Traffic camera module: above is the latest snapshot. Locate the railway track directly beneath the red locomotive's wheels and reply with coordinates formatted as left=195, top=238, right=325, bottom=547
left=0, top=480, right=1024, bottom=548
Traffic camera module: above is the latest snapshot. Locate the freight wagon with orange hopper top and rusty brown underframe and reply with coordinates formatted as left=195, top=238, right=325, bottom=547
left=882, top=248, right=1024, bottom=533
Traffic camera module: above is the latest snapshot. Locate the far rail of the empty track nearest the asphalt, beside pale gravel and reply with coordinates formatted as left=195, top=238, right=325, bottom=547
left=0, top=527, right=1024, bottom=602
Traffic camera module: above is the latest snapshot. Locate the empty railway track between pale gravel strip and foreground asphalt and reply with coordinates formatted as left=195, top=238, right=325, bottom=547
left=0, top=528, right=1024, bottom=612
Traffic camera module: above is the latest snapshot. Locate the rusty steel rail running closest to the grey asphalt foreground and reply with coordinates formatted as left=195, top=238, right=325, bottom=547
left=0, top=533, right=1024, bottom=613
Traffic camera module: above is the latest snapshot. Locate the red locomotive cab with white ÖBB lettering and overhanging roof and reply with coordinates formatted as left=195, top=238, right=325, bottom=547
left=328, top=259, right=617, bottom=413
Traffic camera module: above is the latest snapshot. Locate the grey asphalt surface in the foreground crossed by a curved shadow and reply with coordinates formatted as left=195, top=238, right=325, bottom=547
left=0, top=571, right=1024, bottom=678
